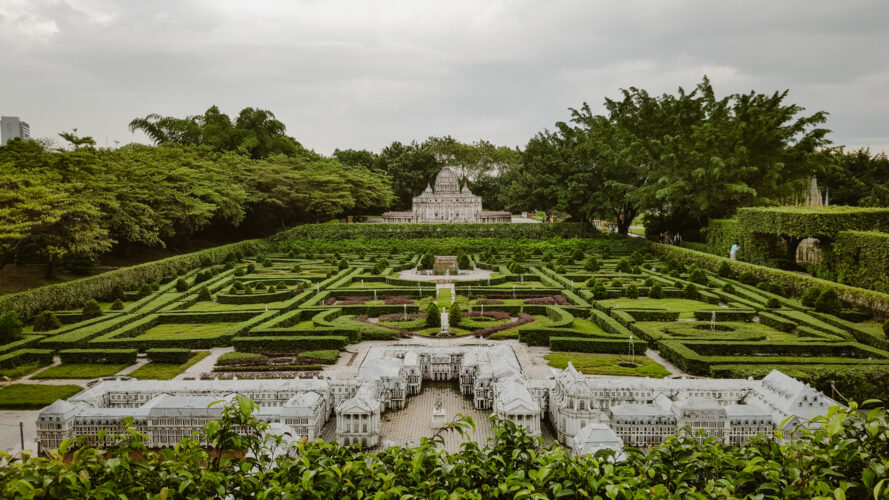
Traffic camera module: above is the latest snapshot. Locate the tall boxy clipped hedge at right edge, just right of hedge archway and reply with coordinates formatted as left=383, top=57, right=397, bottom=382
left=831, top=231, right=889, bottom=292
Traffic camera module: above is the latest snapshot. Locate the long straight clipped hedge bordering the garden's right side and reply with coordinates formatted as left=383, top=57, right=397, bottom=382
left=651, top=243, right=889, bottom=317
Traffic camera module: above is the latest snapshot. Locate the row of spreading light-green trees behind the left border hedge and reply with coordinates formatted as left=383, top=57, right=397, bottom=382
left=0, top=141, right=393, bottom=274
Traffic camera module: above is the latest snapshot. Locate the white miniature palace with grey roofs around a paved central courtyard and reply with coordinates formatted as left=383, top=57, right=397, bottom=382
left=37, top=344, right=838, bottom=453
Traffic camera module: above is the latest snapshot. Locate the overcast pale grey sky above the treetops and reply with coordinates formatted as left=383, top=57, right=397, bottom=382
left=0, top=0, right=889, bottom=154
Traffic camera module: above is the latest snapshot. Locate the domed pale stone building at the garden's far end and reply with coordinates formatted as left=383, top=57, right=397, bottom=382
left=383, top=167, right=512, bottom=223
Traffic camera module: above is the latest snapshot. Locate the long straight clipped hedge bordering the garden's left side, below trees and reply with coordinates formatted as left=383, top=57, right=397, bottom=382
left=0, top=240, right=264, bottom=317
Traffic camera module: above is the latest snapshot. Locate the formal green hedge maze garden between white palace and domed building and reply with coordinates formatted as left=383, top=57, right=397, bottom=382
left=0, top=223, right=889, bottom=399
